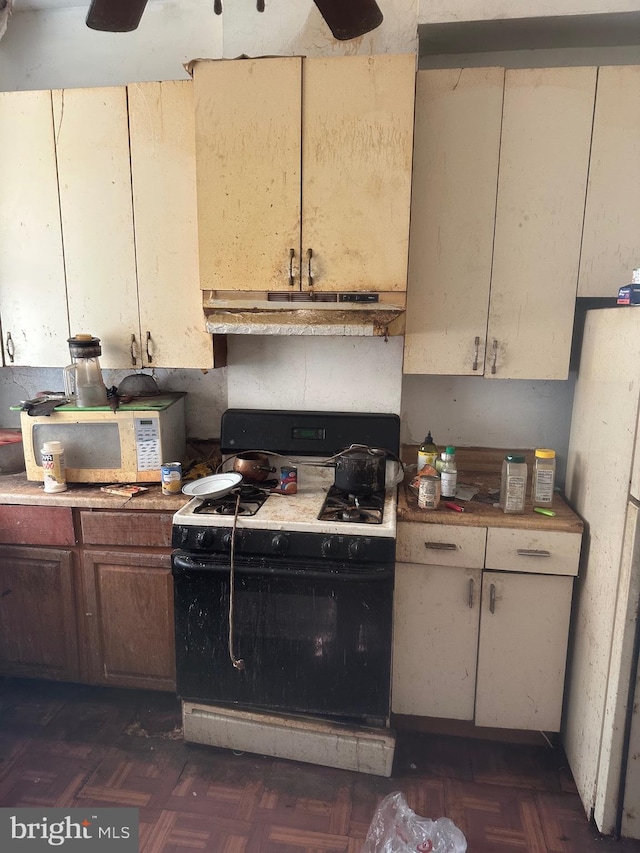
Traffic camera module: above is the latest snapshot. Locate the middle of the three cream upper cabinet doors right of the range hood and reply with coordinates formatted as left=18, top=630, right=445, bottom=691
left=485, top=68, right=596, bottom=379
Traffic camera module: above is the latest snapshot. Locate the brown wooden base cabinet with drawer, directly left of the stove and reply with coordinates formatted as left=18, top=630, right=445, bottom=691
left=80, top=510, right=175, bottom=691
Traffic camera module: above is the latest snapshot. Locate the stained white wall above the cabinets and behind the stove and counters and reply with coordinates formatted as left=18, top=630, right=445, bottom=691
left=0, top=0, right=624, bottom=480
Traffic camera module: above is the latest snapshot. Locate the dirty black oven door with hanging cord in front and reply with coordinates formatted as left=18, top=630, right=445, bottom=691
left=173, top=551, right=393, bottom=725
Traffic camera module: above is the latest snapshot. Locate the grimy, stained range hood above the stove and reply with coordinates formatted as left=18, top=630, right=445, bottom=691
left=203, top=291, right=405, bottom=338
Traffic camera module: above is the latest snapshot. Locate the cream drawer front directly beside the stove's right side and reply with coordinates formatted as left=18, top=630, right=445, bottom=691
left=396, top=521, right=487, bottom=569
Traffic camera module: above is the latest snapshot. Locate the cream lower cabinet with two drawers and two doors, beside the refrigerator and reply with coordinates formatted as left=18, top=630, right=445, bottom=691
left=391, top=522, right=581, bottom=731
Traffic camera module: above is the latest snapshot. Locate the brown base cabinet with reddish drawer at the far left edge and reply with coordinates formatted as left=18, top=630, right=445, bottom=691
left=0, top=506, right=79, bottom=681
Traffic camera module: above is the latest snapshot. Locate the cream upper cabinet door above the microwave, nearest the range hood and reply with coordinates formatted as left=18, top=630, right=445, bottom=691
left=127, top=80, right=213, bottom=369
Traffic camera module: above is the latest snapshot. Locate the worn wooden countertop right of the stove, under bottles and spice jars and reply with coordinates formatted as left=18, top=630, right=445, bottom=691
left=398, top=446, right=584, bottom=534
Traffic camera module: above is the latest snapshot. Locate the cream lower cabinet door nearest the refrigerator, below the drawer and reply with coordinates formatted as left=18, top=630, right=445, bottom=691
left=475, top=572, right=573, bottom=732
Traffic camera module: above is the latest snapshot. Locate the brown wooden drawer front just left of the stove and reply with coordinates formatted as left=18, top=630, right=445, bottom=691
left=80, top=510, right=173, bottom=548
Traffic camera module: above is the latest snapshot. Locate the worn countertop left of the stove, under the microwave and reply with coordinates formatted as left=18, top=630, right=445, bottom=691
left=0, top=472, right=190, bottom=512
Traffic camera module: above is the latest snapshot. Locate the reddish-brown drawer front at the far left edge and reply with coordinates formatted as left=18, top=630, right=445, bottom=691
left=0, top=504, right=76, bottom=545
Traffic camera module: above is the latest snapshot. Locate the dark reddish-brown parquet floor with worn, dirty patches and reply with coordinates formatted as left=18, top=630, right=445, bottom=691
left=0, top=679, right=640, bottom=853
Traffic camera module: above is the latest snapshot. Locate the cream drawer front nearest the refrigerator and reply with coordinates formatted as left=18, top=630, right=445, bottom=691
left=485, top=527, right=582, bottom=575
